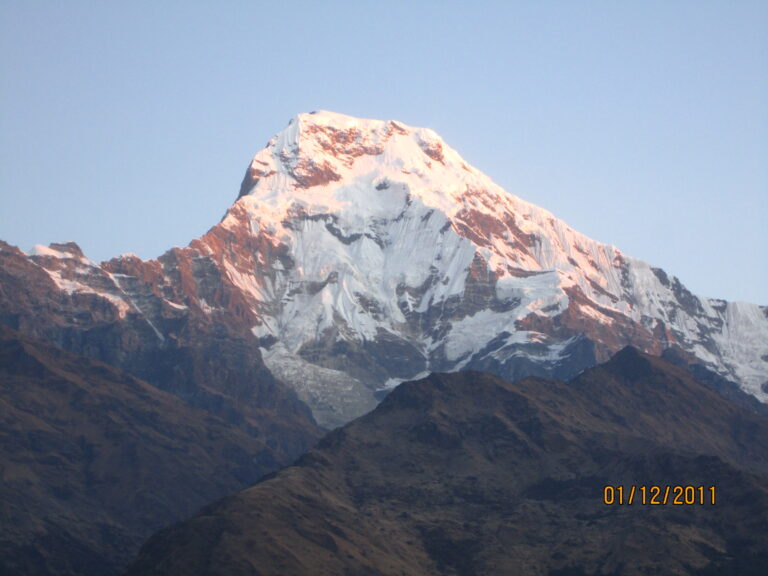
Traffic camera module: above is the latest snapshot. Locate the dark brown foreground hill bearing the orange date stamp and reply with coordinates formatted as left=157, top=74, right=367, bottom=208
left=128, top=348, right=768, bottom=576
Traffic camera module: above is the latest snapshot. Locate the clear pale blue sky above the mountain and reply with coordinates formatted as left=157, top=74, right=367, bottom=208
left=0, top=0, right=768, bottom=304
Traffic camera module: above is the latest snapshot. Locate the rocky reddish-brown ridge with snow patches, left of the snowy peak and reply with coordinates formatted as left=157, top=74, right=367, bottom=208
left=0, top=241, right=321, bottom=450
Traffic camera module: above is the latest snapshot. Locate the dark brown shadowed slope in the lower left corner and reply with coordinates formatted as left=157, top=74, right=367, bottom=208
left=0, top=325, right=316, bottom=576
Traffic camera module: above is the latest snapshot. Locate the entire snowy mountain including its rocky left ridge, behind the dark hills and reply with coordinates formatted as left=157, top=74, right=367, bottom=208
left=0, top=111, right=768, bottom=428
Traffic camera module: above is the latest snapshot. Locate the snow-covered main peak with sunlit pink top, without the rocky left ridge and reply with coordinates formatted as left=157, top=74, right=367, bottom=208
left=195, top=111, right=768, bottom=428
